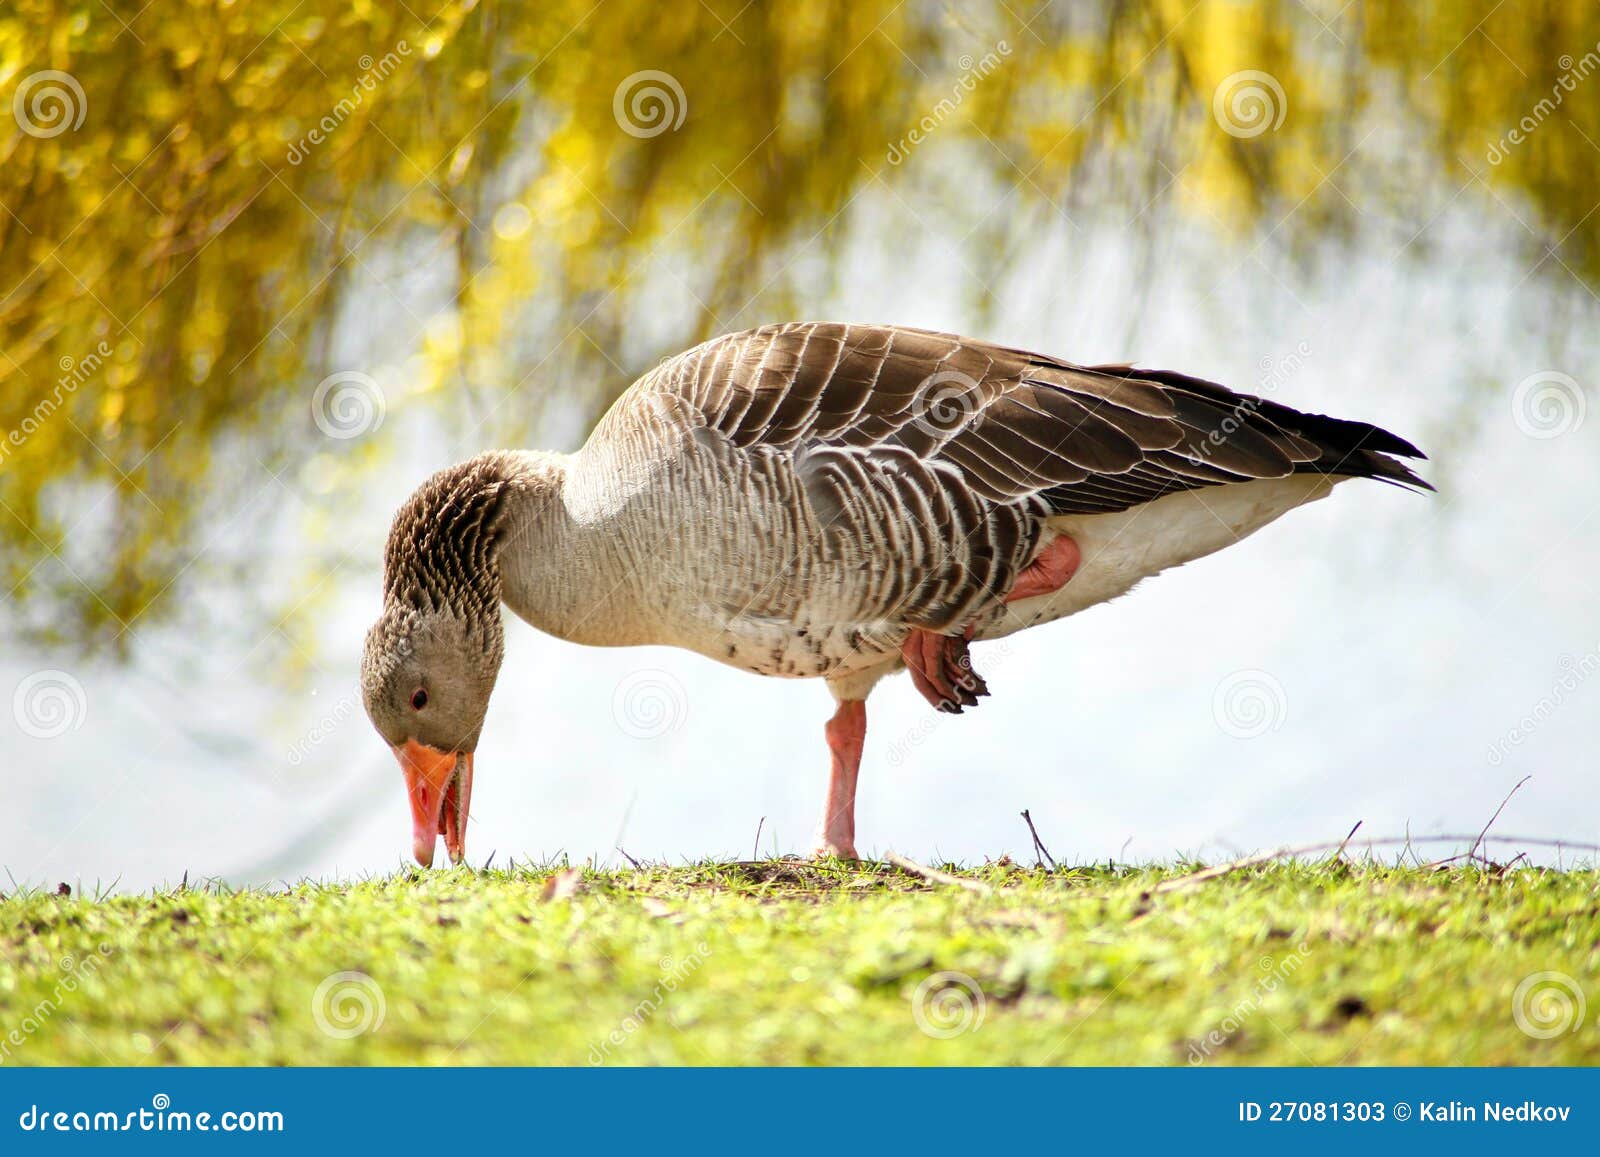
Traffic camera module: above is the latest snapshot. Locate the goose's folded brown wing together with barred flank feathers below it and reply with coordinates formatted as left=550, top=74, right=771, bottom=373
left=637, top=323, right=1426, bottom=631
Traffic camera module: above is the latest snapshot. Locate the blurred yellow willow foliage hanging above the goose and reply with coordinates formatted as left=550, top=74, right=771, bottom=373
left=0, top=0, right=1600, bottom=642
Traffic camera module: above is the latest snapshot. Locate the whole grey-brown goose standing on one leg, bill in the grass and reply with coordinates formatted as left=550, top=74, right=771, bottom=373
left=362, top=322, right=1432, bottom=867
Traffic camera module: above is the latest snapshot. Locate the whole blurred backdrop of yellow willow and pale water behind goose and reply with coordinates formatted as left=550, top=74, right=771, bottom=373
left=0, top=0, right=1600, bottom=890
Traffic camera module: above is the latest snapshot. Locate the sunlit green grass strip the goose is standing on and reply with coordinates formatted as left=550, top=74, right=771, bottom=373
left=0, top=861, right=1600, bottom=1064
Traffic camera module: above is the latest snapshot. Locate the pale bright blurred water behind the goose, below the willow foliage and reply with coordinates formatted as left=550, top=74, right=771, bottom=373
left=0, top=190, right=1600, bottom=888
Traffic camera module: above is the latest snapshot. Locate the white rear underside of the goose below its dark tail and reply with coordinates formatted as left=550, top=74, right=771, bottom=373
left=978, top=474, right=1346, bottom=639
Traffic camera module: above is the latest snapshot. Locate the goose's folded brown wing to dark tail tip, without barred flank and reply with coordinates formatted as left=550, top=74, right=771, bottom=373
left=658, top=323, right=1427, bottom=514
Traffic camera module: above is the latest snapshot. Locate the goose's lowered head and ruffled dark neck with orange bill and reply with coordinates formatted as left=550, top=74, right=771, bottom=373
left=362, top=458, right=510, bottom=867
